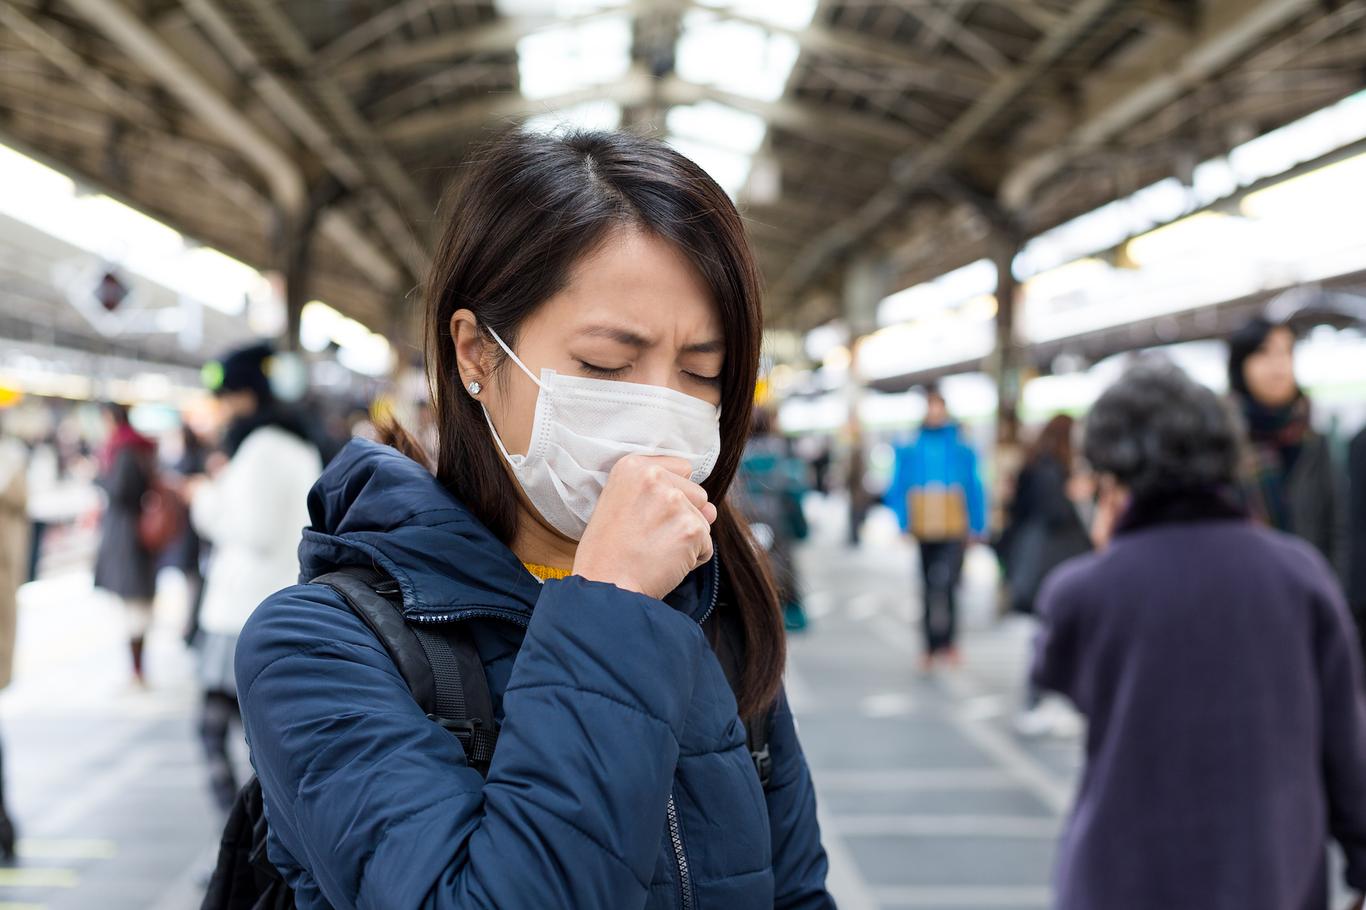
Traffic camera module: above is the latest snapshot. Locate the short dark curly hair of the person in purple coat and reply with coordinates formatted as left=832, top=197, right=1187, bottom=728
left=1085, top=363, right=1239, bottom=499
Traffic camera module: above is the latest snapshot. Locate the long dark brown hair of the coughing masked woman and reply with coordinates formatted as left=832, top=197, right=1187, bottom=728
left=390, top=131, right=785, bottom=717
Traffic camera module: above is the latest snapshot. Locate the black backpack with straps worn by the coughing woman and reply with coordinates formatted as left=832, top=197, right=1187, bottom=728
left=201, top=567, right=773, bottom=910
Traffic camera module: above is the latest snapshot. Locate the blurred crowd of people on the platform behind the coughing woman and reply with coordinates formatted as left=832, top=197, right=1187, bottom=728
left=0, top=310, right=1366, bottom=907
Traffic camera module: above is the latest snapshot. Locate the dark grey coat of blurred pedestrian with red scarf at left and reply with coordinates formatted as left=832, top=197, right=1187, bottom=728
left=94, top=428, right=157, bottom=600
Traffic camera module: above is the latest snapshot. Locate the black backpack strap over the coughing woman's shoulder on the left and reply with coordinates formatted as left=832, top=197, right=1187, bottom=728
left=313, top=567, right=499, bottom=775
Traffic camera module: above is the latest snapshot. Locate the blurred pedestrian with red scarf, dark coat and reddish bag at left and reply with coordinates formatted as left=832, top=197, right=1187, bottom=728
left=94, top=402, right=157, bottom=686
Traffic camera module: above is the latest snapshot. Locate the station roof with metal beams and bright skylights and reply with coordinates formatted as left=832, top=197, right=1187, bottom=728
left=0, top=0, right=1366, bottom=329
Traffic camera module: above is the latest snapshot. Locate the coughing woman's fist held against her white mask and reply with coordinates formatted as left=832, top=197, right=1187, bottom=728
left=574, top=455, right=716, bottom=598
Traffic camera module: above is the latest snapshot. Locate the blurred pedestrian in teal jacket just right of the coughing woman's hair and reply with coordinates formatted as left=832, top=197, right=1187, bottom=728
left=739, top=407, right=809, bottom=631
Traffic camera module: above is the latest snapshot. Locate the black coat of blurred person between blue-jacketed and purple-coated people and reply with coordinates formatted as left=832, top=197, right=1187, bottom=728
left=1000, top=455, right=1091, bottom=613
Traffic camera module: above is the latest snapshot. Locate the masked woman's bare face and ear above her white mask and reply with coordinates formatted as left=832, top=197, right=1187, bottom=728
left=452, top=230, right=725, bottom=454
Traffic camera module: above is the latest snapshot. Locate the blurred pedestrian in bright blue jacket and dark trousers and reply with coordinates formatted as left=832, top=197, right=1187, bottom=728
left=885, top=387, right=986, bottom=671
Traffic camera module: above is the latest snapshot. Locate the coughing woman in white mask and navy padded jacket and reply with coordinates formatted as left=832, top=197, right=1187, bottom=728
left=236, top=133, right=833, bottom=910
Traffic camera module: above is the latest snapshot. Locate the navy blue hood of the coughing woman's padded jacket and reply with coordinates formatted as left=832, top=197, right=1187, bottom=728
left=299, top=439, right=720, bottom=622
